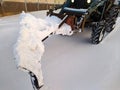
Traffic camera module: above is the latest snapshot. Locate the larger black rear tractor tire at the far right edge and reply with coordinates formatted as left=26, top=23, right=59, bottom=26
left=105, top=6, right=119, bottom=33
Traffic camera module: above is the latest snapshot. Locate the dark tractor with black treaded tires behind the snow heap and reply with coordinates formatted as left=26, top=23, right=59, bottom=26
left=47, top=0, right=119, bottom=44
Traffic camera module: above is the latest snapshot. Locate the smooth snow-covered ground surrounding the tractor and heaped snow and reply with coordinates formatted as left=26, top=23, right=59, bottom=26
left=0, top=11, right=120, bottom=90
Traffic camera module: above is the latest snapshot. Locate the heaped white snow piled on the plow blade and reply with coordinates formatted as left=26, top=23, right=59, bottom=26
left=14, top=13, right=73, bottom=86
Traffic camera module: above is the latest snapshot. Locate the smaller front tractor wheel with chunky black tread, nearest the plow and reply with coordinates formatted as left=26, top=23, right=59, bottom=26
left=91, top=22, right=105, bottom=44
